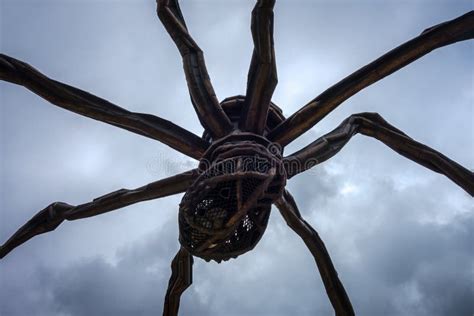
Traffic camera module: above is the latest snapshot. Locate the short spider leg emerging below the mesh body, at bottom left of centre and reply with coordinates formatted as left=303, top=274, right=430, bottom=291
left=163, top=247, right=194, bottom=316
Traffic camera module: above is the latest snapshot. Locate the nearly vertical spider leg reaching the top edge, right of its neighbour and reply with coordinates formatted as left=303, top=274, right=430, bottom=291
left=239, top=0, right=278, bottom=135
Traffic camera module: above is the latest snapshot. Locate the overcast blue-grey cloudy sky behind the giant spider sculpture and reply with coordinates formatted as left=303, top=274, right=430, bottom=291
left=0, top=0, right=474, bottom=316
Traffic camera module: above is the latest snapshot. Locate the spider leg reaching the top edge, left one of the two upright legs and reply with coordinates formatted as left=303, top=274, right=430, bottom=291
left=157, top=0, right=233, bottom=139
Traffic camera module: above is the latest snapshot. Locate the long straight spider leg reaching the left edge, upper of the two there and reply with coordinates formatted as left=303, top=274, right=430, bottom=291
left=0, top=54, right=209, bottom=159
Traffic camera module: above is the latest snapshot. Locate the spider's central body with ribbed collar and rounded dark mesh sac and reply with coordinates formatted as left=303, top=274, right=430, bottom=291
left=179, top=134, right=286, bottom=262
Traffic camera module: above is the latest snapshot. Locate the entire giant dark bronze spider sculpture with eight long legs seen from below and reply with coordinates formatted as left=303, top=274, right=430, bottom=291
left=0, top=0, right=474, bottom=315
